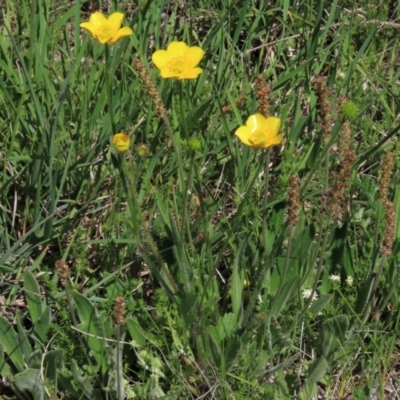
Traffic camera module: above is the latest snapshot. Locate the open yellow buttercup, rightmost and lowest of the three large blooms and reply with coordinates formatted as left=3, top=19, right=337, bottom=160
left=235, top=114, right=282, bottom=149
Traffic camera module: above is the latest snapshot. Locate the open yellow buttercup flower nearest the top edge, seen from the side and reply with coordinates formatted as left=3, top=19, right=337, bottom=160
left=80, top=11, right=133, bottom=44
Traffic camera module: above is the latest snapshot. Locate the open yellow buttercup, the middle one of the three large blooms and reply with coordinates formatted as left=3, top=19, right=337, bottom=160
left=151, top=42, right=204, bottom=79
